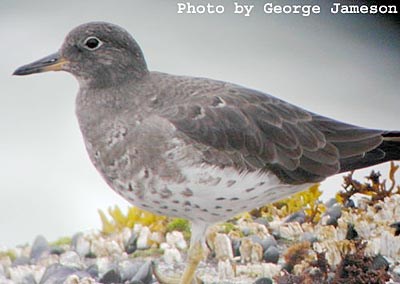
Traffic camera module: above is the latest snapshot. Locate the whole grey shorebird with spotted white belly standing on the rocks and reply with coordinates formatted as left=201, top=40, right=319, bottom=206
left=14, top=22, right=400, bottom=283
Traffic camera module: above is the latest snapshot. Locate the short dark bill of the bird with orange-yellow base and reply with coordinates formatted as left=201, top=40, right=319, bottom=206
left=13, top=52, right=68, bottom=75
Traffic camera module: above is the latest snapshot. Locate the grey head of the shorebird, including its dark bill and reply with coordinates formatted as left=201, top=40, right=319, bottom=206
left=14, top=22, right=148, bottom=87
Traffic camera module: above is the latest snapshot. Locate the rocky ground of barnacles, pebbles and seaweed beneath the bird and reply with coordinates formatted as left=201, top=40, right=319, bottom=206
left=0, top=171, right=400, bottom=284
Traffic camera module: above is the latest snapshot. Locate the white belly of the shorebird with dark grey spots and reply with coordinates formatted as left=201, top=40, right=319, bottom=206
left=117, top=164, right=311, bottom=223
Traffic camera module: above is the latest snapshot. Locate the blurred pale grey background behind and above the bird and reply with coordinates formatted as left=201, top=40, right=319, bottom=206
left=0, top=0, right=400, bottom=248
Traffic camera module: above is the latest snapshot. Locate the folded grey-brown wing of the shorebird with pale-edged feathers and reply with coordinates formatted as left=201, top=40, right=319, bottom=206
left=162, top=84, right=384, bottom=184
